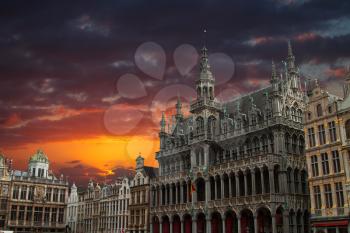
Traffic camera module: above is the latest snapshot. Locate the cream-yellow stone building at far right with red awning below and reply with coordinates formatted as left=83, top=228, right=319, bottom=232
left=304, top=69, right=350, bottom=233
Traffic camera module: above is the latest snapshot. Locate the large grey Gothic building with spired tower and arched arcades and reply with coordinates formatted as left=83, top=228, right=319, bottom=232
left=151, top=43, right=310, bottom=233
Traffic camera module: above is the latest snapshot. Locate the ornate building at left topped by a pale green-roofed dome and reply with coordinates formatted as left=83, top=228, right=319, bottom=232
left=7, top=150, right=68, bottom=233
